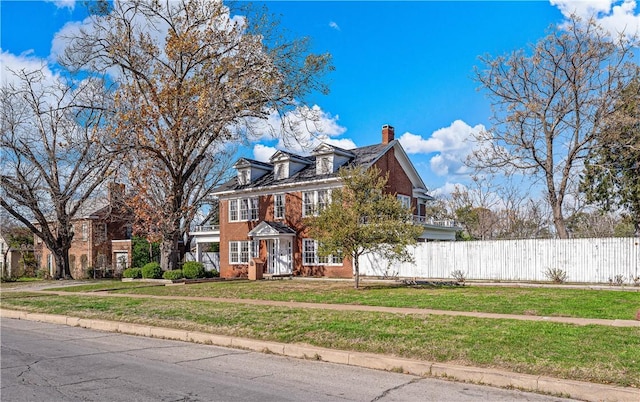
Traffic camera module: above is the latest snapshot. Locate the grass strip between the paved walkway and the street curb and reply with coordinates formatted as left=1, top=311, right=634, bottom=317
left=2, top=288, right=640, bottom=387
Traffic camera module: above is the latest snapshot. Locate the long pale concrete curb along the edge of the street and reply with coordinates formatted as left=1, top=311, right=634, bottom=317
left=0, top=309, right=640, bottom=402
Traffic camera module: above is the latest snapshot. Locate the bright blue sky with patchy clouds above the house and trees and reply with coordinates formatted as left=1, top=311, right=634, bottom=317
left=0, top=0, right=640, bottom=192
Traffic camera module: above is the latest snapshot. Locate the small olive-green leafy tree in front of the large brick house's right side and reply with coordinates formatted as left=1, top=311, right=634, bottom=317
left=307, top=166, right=423, bottom=289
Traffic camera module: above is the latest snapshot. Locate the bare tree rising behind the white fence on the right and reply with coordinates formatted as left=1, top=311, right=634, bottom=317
left=469, top=17, right=637, bottom=238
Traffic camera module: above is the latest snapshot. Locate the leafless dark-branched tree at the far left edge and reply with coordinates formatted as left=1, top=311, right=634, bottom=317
left=0, top=70, right=112, bottom=278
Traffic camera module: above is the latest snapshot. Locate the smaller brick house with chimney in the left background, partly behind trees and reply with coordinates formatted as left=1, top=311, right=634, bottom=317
left=34, top=183, right=132, bottom=279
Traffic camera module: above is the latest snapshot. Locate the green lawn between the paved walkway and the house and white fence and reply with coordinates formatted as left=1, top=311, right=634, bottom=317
left=45, top=280, right=640, bottom=320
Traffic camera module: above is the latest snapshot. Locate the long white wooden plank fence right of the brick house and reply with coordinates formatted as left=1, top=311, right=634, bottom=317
left=360, top=238, right=640, bottom=284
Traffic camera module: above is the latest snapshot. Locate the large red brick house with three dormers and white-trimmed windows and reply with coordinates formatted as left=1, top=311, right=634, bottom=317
left=208, top=125, right=457, bottom=278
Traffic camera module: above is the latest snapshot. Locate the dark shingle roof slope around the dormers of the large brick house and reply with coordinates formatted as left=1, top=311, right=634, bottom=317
left=213, top=144, right=391, bottom=194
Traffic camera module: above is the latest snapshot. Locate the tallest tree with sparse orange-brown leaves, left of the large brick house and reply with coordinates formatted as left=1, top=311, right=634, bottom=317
left=63, top=0, right=330, bottom=269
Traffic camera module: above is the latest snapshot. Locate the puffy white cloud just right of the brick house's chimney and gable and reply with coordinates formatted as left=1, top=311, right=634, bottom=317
left=398, top=120, right=485, bottom=176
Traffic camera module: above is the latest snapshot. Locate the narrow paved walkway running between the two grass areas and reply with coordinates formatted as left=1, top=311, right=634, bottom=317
left=18, top=289, right=640, bottom=327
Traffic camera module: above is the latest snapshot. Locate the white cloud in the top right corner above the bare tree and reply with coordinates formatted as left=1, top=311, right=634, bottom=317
left=550, top=0, right=640, bottom=37
